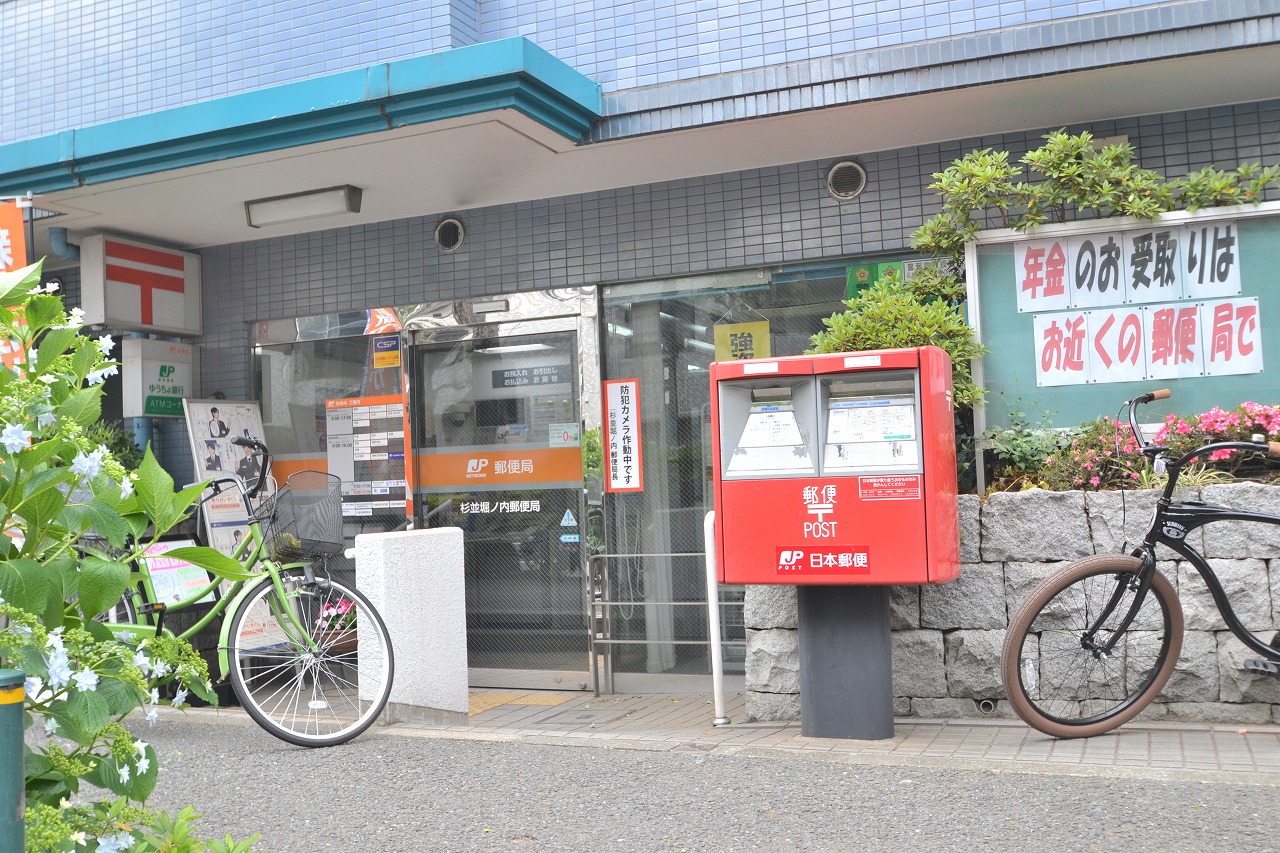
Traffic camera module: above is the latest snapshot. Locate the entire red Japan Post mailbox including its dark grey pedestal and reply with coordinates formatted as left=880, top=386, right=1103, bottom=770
left=710, top=347, right=960, bottom=739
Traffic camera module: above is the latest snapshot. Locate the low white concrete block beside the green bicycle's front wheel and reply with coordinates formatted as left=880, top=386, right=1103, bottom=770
left=356, top=528, right=467, bottom=725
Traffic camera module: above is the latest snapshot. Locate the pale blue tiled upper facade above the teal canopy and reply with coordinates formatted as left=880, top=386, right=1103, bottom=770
left=0, top=0, right=1244, bottom=143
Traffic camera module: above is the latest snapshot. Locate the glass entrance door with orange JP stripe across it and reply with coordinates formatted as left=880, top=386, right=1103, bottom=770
left=410, top=330, right=590, bottom=689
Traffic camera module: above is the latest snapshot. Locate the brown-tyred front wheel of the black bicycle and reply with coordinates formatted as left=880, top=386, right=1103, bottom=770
left=1001, top=555, right=1183, bottom=738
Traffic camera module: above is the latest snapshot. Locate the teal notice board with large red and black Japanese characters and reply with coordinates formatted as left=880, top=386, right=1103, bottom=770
left=966, top=201, right=1280, bottom=429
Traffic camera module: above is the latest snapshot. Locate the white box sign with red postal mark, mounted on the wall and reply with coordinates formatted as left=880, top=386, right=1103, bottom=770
left=81, top=234, right=204, bottom=336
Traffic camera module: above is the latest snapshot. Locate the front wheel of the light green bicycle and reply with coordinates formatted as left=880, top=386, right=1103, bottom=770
left=229, top=569, right=394, bottom=747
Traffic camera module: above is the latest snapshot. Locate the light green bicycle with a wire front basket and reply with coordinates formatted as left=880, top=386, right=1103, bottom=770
left=108, top=437, right=394, bottom=747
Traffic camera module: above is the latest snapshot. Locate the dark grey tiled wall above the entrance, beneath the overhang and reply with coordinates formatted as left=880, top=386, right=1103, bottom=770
left=201, top=100, right=1280, bottom=397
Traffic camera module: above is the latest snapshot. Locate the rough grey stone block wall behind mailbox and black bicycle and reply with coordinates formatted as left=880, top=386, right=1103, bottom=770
left=744, top=483, right=1280, bottom=725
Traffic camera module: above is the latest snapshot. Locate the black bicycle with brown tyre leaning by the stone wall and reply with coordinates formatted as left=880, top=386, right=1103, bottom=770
left=1001, top=391, right=1280, bottom=738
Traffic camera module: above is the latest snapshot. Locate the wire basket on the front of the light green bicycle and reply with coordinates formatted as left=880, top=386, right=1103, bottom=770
left=255, top=471, right=344, bottom=562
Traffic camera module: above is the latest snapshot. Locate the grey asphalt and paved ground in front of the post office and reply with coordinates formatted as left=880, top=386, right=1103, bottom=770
left=137, top=694, right=1280, bottom=853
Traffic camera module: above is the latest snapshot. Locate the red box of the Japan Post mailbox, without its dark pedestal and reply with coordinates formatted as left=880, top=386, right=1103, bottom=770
left=710, top=347, right=960, bottom=584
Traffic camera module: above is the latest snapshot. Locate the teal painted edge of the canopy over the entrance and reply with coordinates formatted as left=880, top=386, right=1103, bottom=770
left=0, top=37, right=603, bottom=195
